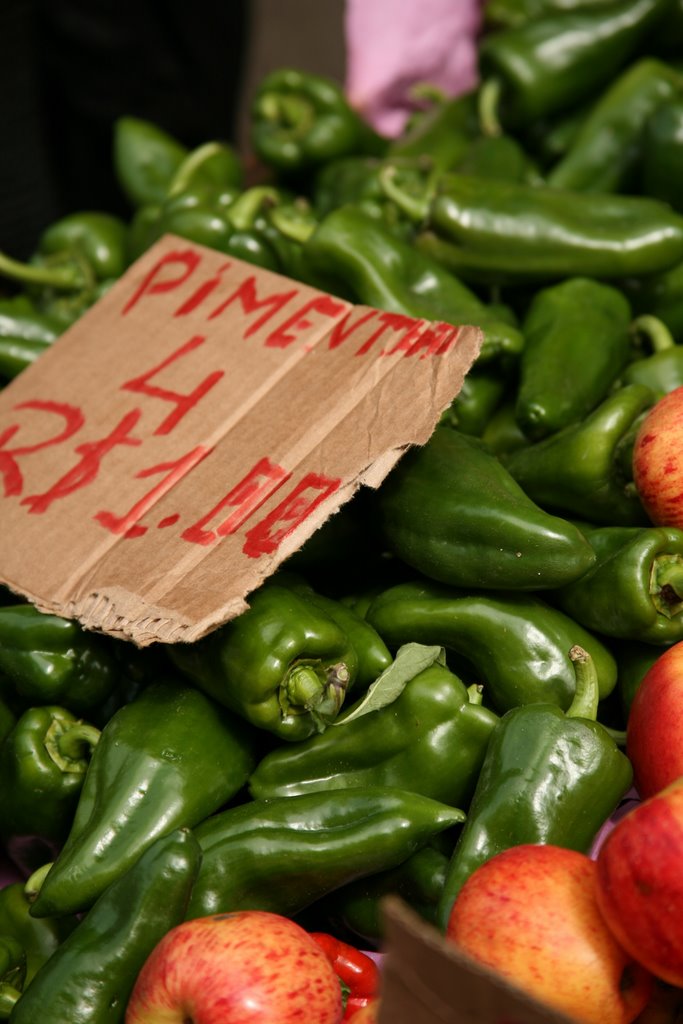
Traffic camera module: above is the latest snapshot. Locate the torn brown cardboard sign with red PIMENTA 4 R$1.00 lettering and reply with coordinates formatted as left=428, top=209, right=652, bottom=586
left=0, top=236, right=481, bottom=646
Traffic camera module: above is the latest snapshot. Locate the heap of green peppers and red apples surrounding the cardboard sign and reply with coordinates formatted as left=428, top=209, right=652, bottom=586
left=0, top=0, right=683, bottom=1024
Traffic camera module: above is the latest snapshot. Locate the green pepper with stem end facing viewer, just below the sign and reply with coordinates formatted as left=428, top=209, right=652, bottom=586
left=169, top=581, right=357, bottom=740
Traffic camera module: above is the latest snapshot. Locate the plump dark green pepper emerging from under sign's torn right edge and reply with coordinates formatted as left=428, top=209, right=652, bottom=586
left=377, top=425, right=595, bottom=590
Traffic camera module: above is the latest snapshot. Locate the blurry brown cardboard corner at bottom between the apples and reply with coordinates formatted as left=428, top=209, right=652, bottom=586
left=378, top=896, right=577, bottom=1024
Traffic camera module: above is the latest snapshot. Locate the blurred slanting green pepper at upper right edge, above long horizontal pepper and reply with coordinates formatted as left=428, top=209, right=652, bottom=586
left=546, top=57, right=683, bottom=192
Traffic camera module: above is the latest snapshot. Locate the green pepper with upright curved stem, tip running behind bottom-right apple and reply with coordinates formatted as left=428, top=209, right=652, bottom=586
left=438, top=647, right=633, bottom=928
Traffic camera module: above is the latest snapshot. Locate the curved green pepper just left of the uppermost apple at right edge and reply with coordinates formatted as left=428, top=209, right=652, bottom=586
left=500, top=384, right=655, bottom=528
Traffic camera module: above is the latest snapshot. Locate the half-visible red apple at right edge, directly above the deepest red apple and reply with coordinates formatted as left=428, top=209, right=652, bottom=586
left=626, top=642, right=683, bottom=800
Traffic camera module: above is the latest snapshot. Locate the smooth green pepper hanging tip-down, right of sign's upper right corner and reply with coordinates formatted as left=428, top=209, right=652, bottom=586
left=515, top=278, right=632, bottom=440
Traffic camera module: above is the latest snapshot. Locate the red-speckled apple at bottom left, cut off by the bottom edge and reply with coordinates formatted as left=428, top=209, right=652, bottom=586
left=126, top=910, right=343, bottom=1024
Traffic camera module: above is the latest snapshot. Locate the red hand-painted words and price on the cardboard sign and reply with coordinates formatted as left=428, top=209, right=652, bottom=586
left=0, top=249, right=459, bottom=558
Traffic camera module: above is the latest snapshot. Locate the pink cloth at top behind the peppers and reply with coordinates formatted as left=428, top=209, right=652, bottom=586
left=344, top=0, right=481, bottom=137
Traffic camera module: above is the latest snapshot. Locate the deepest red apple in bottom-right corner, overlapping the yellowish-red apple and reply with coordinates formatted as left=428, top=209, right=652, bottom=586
left=597, top=778, right=683, bottom=987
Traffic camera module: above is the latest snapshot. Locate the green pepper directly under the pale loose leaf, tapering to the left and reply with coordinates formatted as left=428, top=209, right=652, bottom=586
left=249, top=665, right=498, bottom=807
